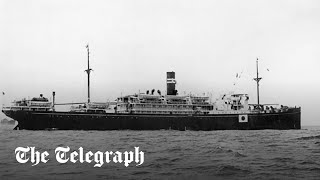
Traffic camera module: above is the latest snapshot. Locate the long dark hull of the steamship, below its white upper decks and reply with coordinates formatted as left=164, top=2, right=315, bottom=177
left=4, top=108, right=301, bottom=131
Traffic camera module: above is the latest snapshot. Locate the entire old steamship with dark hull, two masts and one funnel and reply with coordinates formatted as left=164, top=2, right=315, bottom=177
left=2, top=46, right=301, bottom=131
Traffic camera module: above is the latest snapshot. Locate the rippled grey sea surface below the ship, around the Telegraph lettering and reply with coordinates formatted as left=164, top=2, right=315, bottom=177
left=0, top=125, right=320, bottom=179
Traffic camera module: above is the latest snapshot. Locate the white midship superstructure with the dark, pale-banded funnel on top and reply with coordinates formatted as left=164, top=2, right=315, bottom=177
left=115, top=72, right=213, bottom=114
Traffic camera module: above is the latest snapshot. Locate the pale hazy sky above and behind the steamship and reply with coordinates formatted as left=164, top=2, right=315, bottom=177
left=0, top=0, right=320, bottom=125
